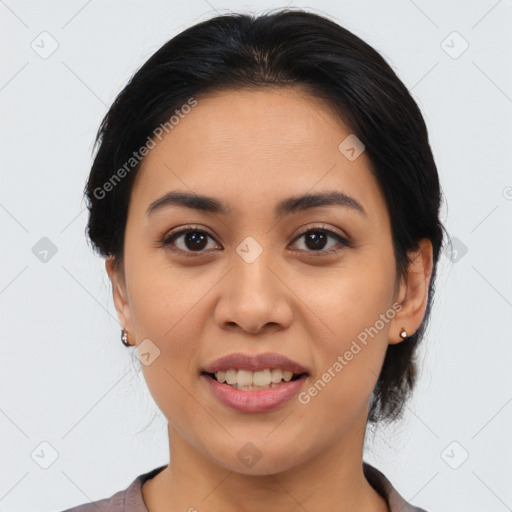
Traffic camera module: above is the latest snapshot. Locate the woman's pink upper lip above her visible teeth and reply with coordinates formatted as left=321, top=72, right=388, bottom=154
left=203, top=352, right=308, bottom=374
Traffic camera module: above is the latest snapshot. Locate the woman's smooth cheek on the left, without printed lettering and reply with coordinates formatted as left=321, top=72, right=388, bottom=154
left=128, top=259, right=209, bottom=404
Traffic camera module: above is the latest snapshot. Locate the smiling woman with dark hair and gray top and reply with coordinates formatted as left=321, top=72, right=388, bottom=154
left=60, top=10, right=444, bottom=512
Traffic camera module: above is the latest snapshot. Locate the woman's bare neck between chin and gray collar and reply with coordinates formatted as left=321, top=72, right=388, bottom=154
left=142, top=412, right=388, bottom=512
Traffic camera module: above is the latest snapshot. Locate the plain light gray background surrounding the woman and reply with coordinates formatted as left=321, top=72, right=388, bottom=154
left=0, top=0, right=512, bottom=512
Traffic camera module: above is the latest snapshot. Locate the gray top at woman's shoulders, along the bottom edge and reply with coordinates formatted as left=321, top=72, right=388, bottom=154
left=62, top=462, right=427, bottom=512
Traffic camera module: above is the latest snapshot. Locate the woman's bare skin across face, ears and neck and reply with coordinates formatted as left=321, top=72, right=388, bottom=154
left=106, top=88, right=432, bottom=512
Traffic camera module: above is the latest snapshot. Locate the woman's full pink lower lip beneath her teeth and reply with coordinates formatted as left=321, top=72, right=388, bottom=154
left=201, top=374, right=307, bottom=412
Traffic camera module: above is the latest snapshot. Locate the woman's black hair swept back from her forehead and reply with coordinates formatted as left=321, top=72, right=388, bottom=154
left=85, top=9, right=445, bottom=423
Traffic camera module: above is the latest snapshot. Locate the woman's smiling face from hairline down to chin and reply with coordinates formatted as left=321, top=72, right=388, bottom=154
left=107, top=89, right=428, bottom=474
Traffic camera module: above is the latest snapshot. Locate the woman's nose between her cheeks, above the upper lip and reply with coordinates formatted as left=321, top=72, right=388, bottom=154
left=215, top=251, right=293, bottom=334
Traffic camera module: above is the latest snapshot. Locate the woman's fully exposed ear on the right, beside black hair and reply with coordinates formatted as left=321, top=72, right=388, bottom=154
left=389, top=238, right=433, bottom=345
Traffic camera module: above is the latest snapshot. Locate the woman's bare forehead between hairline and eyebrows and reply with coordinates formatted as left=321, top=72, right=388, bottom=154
left=132, top=88, right=385, bottom=222
